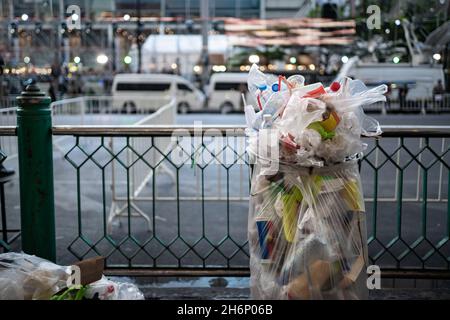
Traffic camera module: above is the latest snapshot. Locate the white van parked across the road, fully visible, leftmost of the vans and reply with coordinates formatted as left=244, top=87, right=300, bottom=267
left=111, top=73, right=205, bottom=113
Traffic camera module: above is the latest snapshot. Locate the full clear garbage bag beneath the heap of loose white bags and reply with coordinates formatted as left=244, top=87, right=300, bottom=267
left=248, top=162, right=368, bottom=299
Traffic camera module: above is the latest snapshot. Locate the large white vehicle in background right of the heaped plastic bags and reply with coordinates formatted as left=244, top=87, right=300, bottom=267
left=336, top=57, right=445, bottom=100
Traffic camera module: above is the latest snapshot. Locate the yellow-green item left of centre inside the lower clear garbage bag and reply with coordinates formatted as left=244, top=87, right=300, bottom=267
left=281, top=186, right=303, bottom=242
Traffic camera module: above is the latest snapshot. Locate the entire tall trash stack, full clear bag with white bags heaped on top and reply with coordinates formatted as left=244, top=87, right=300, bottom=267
left=245, top=65, right=387, bottom=299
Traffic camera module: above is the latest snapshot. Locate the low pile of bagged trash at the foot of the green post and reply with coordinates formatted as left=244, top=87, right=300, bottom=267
left=0, top=252, right=144, bottom=300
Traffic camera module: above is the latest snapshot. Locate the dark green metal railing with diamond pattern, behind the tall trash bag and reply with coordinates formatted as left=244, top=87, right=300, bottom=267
left=0, top=113, right=450, bottom=277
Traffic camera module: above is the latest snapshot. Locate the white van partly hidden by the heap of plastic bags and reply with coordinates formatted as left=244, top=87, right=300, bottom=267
left=207, top=72, right=252, bottom=113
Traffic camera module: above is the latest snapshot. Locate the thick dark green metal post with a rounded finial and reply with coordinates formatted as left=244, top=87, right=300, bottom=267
left=17, top=84, right=56, bottom=261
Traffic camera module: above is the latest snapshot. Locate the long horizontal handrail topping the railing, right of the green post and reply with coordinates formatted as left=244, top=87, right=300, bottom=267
left=53, top=125, right=450, bottom=137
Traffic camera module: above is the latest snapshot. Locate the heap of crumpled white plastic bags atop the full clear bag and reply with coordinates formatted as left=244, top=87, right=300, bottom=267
left=245, top=65, right=387, bottom=166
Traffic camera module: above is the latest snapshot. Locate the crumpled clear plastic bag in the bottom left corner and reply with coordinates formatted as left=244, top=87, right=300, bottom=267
left=0, top=252, right=71, bottom=300
